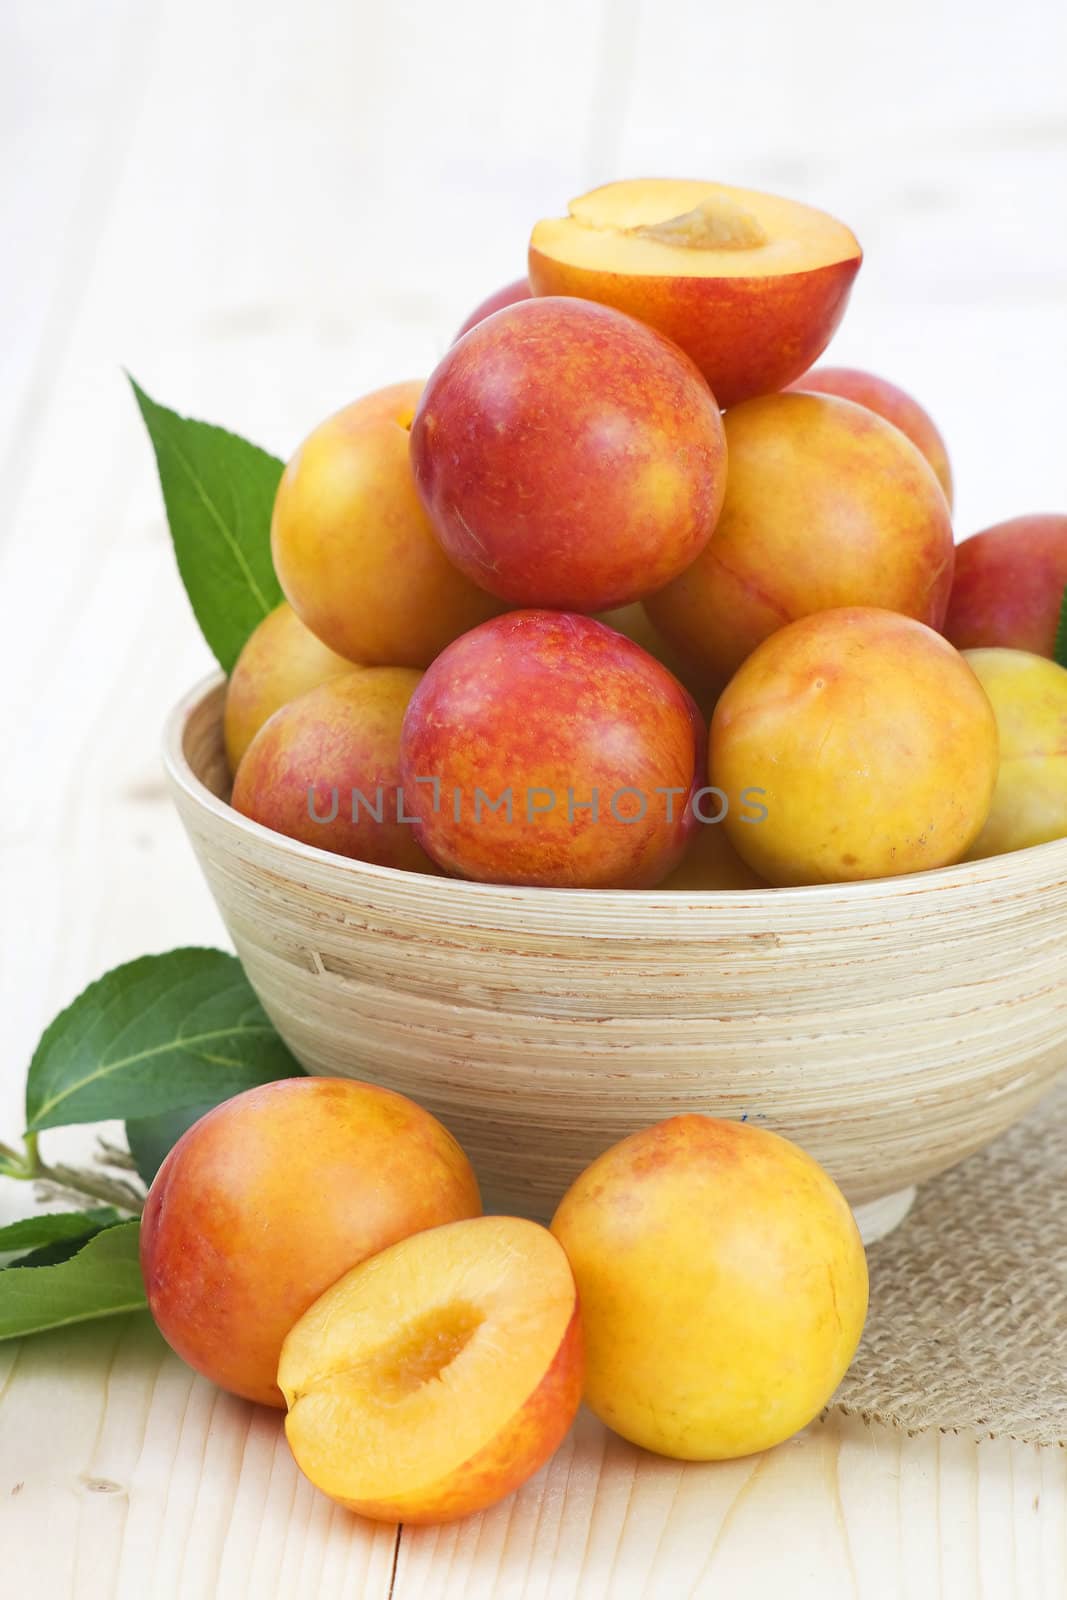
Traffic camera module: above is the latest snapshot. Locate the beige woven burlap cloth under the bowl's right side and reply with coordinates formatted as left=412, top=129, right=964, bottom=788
left=832, top=1075, right=1067, bottom=1445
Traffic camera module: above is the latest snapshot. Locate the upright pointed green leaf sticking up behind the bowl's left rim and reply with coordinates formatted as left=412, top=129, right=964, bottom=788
left=130, top=378, right=285, bottom=672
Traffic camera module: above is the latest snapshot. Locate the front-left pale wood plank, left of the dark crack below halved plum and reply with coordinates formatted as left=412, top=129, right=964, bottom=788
left=0, top=1315, right=397, bottom=1600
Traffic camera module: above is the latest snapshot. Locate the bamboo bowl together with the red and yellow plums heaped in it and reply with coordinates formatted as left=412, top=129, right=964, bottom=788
left=168, top=181, right=1067, bottom=1232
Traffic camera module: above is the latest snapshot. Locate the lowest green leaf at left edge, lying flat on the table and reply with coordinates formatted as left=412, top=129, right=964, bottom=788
left=0, top=1222, right=146, bottom=1339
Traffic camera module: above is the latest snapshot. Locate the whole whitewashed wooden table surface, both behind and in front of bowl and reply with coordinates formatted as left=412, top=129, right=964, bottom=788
left=0, top=0, right=1067, bottom=1600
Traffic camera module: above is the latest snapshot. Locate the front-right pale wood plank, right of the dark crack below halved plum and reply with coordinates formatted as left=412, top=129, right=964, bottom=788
left=394, top=1414, right=1067, bottom=1600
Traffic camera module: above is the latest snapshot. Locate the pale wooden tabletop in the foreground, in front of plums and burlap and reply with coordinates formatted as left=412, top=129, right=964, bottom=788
left=0, top=1315, right=1067, bottom=1600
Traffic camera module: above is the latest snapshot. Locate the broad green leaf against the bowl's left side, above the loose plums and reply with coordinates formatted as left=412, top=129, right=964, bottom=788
left=26, top=949, right=301, bottom=1133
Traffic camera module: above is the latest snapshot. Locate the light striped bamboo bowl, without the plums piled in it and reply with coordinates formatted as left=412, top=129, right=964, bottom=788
left=165, top=677, right=1067, bottom=1242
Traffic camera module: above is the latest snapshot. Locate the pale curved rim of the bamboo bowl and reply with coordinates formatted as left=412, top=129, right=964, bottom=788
left=163, top=672, right=1067, bottom=931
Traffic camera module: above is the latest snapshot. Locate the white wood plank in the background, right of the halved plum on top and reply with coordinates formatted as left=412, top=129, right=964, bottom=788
left=607, top=0, right=1067, bottom=534
